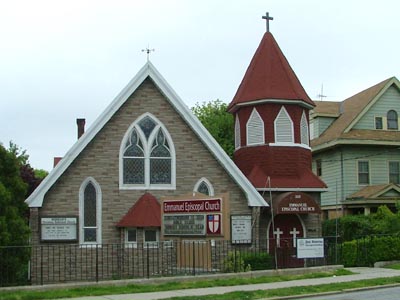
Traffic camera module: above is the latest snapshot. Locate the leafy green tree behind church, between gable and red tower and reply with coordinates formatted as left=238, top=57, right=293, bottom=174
left=192, top=99, right=235, bottom=157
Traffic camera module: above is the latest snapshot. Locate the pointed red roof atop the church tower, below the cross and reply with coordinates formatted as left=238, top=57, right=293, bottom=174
left=228, top=32, right=314, bottom=112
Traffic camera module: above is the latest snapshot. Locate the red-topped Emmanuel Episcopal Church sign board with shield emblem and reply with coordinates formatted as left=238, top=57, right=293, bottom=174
left=162, top=199, right=222, bottom=236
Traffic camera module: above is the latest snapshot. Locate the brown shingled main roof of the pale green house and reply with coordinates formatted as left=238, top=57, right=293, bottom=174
left=311, top=77, right=400, bottom=152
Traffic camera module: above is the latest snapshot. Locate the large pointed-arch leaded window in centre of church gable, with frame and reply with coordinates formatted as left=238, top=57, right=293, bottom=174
left=120, top=114, right=175, bottom=189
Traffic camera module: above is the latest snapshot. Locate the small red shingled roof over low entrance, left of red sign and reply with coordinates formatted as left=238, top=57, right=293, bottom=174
left=117, top=193, right=161, bottom=227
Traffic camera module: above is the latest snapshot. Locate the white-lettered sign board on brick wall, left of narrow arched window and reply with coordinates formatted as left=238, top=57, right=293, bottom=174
left=40, top=217, right=78, bottom=242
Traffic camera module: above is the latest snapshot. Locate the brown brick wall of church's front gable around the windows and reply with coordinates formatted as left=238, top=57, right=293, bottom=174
left=36, top=79, right=251, bottom=243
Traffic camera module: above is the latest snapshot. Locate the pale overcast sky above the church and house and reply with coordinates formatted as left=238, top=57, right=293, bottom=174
left=0, top=0, right=400, bottom=171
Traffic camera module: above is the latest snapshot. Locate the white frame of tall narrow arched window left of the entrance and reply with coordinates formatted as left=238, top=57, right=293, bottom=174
left=79, top=177, right=102, bottom=245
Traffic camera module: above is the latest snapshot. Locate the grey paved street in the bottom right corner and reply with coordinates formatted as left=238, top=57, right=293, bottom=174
left=296, top=286, right=400, bottom=300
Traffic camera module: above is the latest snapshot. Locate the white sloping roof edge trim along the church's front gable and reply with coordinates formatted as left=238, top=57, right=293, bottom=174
left=26, top=61, right=268, bottom=207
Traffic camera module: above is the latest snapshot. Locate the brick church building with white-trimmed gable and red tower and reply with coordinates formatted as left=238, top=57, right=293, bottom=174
left=26, top=14, right=326, bottom=280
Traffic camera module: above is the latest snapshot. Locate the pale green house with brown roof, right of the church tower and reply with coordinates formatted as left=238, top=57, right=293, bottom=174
left=310, top=77, right=400, bottom=218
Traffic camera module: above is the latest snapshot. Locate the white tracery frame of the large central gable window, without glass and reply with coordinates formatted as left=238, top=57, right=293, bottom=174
left=119, top=113, right=176, bottom=190
